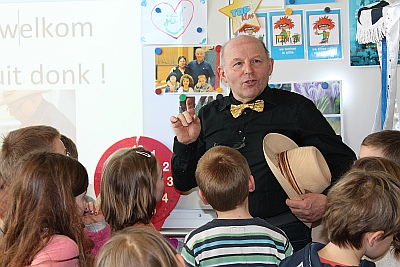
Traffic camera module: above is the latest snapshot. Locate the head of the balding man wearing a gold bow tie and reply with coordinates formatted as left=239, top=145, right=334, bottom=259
left=218, top=35, right=274, bottom=103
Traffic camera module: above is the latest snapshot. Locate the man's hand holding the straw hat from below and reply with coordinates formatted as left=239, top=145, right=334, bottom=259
left=286, top=193, right=326, bottom=222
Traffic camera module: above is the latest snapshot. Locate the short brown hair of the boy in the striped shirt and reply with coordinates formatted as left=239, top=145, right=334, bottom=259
left=196, top=146, right=251, bottom=211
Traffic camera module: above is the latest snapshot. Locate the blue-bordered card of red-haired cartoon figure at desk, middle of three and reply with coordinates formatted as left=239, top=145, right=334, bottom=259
left=269, top=10, right=304, bottom=60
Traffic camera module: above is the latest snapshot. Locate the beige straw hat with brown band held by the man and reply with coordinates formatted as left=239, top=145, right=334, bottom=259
left=263, top=133, right=331, bottom=199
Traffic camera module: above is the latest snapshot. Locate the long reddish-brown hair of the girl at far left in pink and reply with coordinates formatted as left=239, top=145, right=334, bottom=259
left=0, top=152, right=92, bottom=266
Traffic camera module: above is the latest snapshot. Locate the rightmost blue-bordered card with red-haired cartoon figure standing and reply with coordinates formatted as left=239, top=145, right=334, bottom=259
left=306, top=9, right=343, bottom=60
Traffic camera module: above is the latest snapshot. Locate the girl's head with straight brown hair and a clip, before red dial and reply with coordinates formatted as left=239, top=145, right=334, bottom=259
left=100, top=147, right=164, bottom=231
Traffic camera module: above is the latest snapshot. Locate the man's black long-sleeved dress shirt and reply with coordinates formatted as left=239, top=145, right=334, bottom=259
left=172, top=87, right=356, bottom=218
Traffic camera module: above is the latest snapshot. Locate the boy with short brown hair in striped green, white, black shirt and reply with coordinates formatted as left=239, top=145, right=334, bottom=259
left=182, top=146, right=292, bottom=266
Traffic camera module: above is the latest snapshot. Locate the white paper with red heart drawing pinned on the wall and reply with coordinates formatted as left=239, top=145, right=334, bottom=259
left=141, top=0, right=207, bottom=45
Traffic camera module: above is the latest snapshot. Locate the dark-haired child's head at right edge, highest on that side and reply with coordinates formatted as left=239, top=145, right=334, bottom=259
left=359, top=130, right=400, bottom=165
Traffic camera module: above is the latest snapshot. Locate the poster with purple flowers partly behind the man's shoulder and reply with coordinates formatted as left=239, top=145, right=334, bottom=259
left=269, top=81, right=343, bottom=137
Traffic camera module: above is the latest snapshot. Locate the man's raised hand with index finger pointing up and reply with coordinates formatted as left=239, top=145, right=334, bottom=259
left=170, top=98, right=201, bottom=144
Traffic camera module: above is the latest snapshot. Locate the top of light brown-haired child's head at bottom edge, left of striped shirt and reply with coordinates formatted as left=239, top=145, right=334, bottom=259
left=96, top=226, right=185, bottom=267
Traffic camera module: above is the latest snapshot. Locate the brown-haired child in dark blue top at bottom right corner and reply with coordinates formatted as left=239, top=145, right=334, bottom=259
left=280, top=168, right=400, bottom=267
